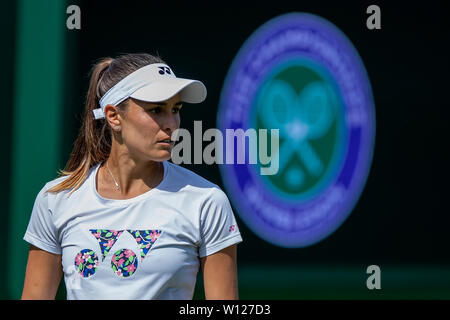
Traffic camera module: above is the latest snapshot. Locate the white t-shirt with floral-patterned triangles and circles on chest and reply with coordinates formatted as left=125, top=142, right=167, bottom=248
left=24, top=161, right=242, bottom=300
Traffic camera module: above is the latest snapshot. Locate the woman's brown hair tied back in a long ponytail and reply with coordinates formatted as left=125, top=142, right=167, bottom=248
left=47, top=53, right=165, bottom=192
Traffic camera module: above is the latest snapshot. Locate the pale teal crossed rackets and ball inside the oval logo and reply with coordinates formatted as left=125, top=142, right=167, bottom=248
left=259, top=79, right=336, bottom=187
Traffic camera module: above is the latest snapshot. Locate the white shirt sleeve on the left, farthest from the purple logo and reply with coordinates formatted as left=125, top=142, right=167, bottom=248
left=23, top=185, right=61, bottom=254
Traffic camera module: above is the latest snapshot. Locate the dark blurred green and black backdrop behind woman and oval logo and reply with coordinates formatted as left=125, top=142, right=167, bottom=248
left=0, top=0, right=450, bottom=299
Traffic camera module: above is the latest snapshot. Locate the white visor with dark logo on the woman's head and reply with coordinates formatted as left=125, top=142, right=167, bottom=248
left=93, top=63, right=206, bottom=119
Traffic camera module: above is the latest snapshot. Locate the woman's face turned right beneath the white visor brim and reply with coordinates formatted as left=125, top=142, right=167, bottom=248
left=120, top=94, right=182, bottom=161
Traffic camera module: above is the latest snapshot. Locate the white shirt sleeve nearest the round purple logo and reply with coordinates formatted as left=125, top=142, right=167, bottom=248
left=199, top=188, right=242, bottom=258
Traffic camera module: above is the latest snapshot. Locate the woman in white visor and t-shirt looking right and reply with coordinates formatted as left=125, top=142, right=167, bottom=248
left=22, top=54, right=242, bottom=300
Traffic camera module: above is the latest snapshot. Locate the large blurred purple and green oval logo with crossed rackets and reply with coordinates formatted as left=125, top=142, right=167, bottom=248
left=217, top=13, right=375, bottom=247
